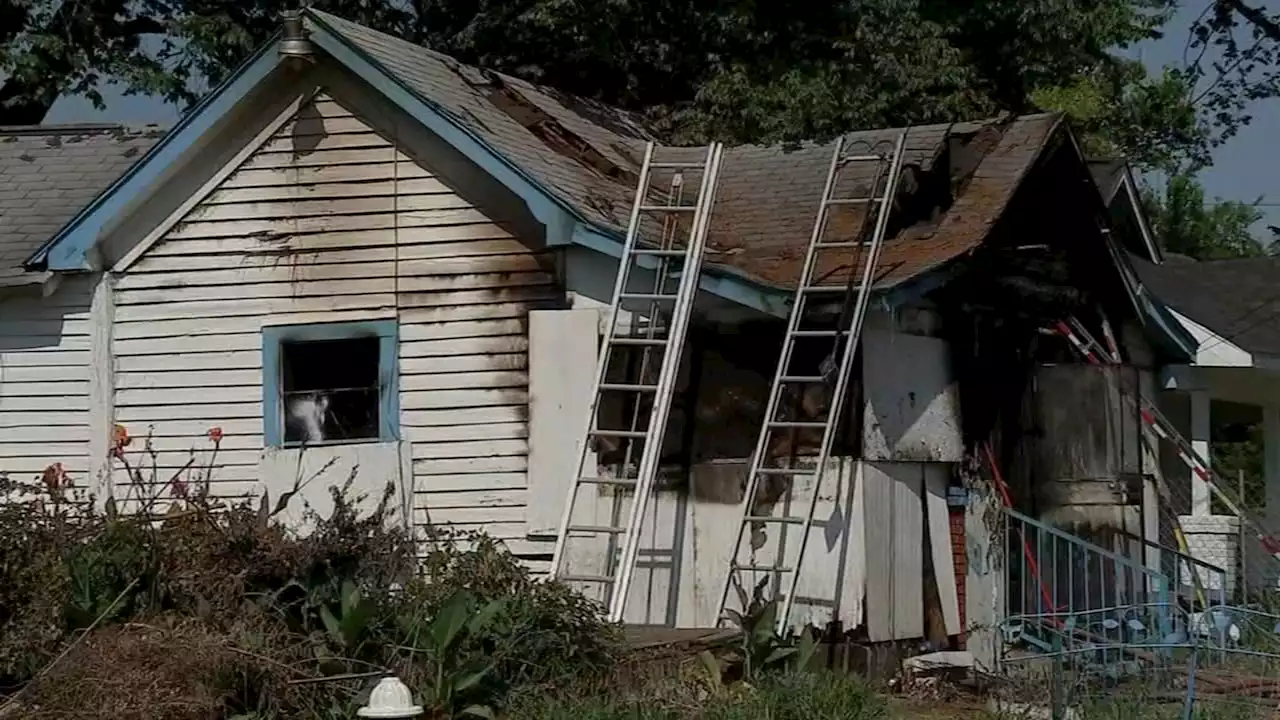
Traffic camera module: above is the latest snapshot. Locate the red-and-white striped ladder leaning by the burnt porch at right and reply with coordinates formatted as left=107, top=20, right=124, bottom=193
left=1048, top=318, right=1280, bottom=566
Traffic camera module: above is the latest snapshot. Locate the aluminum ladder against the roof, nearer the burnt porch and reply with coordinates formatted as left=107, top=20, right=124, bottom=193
left=717, top=131, right=906, bottom=632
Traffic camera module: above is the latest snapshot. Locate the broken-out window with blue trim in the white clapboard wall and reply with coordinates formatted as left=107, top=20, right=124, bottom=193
left=262, top=320, right=399, bottom=447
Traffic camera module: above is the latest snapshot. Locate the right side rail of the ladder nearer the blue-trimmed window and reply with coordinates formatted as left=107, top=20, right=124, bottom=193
left=609, top=142, right=723, bottom=623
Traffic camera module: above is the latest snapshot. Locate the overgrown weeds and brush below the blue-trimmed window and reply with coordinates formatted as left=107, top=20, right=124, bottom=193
left=0, top=432, right=618, bottom=720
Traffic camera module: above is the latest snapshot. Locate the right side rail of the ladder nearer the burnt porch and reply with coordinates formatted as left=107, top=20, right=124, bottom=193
left=778, top=131, right=906, bottom=633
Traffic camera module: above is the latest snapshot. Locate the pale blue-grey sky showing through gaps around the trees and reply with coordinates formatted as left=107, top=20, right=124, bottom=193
left=37, top=0, right=1280, bottom=225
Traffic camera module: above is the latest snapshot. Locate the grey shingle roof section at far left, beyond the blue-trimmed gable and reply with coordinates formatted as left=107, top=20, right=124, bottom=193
left=0, top=124, right=164, bottom=287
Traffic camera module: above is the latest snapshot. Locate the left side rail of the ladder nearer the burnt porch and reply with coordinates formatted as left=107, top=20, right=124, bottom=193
left=716, top=136, right=845, bottom=624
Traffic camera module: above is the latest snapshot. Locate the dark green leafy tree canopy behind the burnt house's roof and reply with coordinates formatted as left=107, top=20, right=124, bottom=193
left=0, top=0, right=1259, bottom=180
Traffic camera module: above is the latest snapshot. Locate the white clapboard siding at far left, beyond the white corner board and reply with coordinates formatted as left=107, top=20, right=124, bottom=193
left=0, top=275, right=95, bottom=487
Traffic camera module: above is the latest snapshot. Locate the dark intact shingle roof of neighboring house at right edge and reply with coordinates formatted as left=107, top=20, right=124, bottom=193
left=1133, top=255, right=1280, bottom=356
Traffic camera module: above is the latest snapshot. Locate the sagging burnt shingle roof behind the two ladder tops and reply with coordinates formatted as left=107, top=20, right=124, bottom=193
left=308, top=9, right=1060, bottom=287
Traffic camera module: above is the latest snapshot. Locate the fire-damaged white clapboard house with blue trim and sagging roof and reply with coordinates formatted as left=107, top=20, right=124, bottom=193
left=0, top=10, right=1194, bottom=656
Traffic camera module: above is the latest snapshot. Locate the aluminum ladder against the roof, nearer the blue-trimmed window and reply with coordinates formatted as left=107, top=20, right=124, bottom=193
left=550, top=142, right=723, bottom=623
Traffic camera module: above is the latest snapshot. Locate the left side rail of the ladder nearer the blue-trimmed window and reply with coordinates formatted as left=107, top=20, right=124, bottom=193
left=548, top=141, right=654, bottom=580
